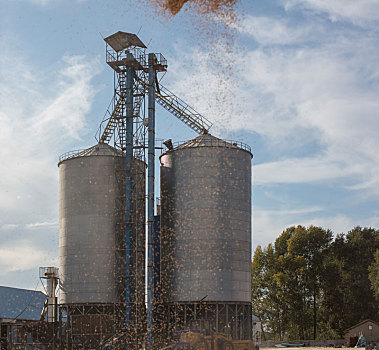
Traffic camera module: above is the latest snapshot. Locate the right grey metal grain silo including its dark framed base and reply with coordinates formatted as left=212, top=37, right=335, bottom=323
left=160, top=134, right=252, bottom=339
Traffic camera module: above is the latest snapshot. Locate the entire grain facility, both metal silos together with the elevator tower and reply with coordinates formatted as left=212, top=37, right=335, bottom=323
left=55, top=32, right=251, bottom=349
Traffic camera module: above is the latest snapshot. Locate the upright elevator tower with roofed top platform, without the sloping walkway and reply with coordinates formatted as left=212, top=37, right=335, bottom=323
left=98, top=32, right=167, bottom=348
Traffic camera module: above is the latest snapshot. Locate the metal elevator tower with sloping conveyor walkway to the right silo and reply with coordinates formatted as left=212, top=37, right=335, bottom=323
left=93, top=32, right=212, bottom=346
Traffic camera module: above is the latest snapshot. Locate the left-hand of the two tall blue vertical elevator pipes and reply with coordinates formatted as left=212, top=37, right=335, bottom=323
left=125, top=54, right=134, bottom=340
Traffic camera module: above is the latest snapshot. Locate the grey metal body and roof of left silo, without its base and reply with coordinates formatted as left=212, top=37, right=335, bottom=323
left=59, top=144, right=145, bottom=304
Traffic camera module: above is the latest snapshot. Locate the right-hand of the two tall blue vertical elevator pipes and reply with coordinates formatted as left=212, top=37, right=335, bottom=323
left=147, top=53, right=156, bottom=348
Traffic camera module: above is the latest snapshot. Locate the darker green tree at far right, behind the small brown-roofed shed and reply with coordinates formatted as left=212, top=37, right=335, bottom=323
left=316, top=227, right=379, bottom=337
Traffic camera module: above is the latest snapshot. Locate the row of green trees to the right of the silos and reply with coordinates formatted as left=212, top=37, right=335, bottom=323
left=252, top=226, right=379, bottom=340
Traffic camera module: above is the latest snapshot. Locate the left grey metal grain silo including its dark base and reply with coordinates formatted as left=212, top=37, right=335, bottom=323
left=58, top=143, right=145, bottom=348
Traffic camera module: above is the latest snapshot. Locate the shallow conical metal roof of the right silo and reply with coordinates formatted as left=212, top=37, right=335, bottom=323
left=168, top=134, right=251, bottom=153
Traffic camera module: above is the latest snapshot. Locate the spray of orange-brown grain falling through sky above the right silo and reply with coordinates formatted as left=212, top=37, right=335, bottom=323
left=142, top=0, right=243, bottom=138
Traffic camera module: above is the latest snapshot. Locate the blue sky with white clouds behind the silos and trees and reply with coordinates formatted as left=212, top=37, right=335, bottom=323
left=0, top=0, right=379, bottom=288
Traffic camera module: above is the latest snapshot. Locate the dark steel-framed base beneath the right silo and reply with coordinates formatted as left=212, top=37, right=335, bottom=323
left=157, top=302, right=252, bottom=340
